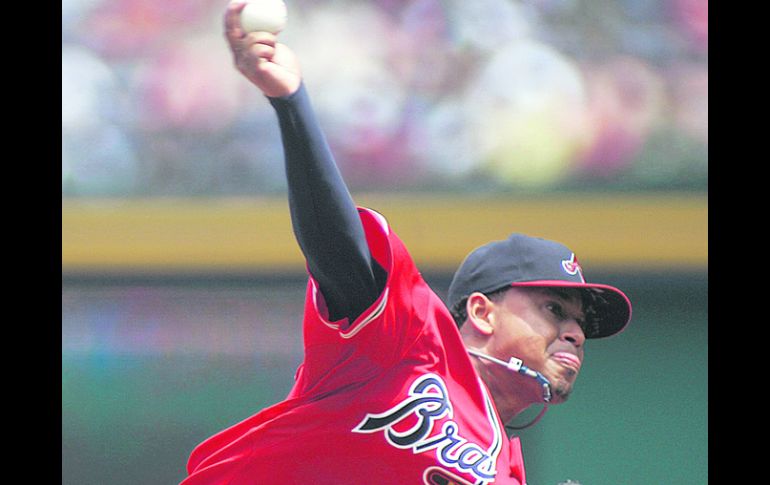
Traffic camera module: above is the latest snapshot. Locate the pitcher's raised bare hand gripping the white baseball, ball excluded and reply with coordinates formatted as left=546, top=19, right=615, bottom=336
left=225, top=2, right=302, bottom=98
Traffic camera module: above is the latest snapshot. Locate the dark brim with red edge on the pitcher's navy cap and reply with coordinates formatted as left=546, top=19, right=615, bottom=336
left=511, top=280, right=631, bottom=338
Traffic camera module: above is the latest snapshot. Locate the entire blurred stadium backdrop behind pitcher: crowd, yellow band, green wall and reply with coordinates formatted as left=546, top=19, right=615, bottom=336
left=61, top=0, right=708, bottom=485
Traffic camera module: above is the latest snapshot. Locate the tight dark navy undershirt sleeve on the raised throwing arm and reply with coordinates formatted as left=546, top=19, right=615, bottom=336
left=268, top=84, right=386, bottom=322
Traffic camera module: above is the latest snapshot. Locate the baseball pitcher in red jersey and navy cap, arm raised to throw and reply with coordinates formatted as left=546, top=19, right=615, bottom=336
left=182, top=4, right=631, bottom=485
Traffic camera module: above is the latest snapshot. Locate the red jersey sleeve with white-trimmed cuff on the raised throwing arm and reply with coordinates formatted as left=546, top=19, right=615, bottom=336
left=292, top=208, right=440, bottom=396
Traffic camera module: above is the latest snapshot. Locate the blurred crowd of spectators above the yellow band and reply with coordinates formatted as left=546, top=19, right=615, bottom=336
left=62, top=0, right=708, bottom=197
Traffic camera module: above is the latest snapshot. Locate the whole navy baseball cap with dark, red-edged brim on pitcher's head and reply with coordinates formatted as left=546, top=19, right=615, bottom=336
left=447, top=234, right=631, bottom=338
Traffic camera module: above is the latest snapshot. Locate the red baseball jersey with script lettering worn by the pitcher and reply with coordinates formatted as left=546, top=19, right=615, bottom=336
left=182, top=209, right=525, bottom=485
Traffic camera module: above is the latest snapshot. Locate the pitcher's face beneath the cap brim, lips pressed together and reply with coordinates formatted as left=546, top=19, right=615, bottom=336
left=494, top=287, right=585, bottom=403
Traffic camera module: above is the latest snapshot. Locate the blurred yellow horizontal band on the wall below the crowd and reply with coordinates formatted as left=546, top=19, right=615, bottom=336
left=62, top=195, right=708, bottom=272
